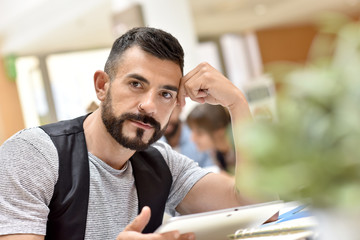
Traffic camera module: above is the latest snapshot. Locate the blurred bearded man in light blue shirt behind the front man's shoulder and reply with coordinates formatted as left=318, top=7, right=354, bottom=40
left=161, top=105, right=219, bottom=172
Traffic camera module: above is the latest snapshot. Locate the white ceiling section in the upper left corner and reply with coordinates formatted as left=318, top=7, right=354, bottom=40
left=0, top=0, right=113, bottom=55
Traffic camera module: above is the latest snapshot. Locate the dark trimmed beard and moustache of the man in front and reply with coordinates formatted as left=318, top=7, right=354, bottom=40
left=101, top=92, right=166, bottom=151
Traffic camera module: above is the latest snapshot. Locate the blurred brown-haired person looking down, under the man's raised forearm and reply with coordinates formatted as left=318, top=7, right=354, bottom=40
left=186, top=104, right=236, bottom=175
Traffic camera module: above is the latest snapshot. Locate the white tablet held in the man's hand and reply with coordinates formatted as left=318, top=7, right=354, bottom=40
left=155, top=201, right=284, bottom=240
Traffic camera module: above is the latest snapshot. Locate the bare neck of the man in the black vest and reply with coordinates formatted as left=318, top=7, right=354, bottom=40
left=84, top=110, right=135, bottom=169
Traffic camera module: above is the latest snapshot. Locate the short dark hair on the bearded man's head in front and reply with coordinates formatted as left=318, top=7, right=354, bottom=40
left=104, top=27, right=184, bottom=79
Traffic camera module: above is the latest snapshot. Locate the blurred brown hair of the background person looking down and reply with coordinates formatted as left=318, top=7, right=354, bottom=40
left=186, top=103, right=231, bottom=133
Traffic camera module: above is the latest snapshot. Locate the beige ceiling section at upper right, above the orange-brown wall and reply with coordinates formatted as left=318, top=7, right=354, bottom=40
left=189, top=0, right=360, bottom=37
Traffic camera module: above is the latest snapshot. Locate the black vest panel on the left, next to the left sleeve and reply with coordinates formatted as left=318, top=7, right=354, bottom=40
left=41, top=116, right=90, bottom=240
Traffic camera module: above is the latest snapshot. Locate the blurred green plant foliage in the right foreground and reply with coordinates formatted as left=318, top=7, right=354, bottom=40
left=237, top=13, right=360, bottom=209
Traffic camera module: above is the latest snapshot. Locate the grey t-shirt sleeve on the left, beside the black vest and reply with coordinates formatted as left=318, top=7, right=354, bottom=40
left=0, top=128, right=58, bottom=235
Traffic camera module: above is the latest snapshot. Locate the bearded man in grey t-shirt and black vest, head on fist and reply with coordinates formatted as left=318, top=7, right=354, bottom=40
left=0, top=27, right=250, bottom=240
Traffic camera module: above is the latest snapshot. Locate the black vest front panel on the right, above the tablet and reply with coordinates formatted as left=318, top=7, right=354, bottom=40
left=130, top=147, right=172, bottom=233
